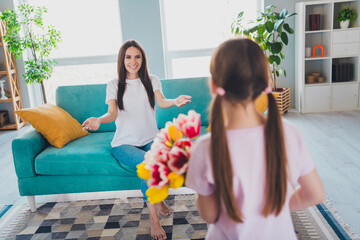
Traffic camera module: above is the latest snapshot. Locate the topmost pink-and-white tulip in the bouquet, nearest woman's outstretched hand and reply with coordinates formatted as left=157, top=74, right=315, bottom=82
left=174, top=110, right=200, bottom=138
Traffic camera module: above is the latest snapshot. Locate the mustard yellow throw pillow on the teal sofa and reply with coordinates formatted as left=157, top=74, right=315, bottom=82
left=15, top=104, right=90, bottom=148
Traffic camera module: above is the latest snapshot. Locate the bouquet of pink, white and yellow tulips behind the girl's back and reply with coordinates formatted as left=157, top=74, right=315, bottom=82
left=137, top=110, right=200, bottom=204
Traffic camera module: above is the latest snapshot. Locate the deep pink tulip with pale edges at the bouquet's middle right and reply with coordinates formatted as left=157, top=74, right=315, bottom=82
left=168, top=146, right=190, bottom=175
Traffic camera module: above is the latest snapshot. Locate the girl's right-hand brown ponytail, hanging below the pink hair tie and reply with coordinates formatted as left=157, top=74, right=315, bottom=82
left=262, top=93, right=287, bottom=217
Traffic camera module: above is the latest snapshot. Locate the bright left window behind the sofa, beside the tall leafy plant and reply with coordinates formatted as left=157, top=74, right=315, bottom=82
left=28, top=0, right=122, bottom=103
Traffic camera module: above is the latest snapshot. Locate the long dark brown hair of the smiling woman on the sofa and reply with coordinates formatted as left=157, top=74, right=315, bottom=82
left=117, top=40, right=155, bottom=110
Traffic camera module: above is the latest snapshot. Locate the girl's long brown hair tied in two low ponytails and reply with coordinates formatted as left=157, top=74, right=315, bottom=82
left=210, top=38, right=287, bottom=222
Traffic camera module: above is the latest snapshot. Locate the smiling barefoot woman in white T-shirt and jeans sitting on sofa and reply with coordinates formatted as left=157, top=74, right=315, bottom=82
left=83, top=40, right=191, bottom=239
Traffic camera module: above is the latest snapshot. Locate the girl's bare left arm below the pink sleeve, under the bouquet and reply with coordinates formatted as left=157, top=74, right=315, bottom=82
left=196, top=193, right=220, bottom=223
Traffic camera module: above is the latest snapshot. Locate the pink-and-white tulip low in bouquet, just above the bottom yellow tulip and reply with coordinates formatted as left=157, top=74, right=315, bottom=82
left=147, top=162, right=170, bottom=188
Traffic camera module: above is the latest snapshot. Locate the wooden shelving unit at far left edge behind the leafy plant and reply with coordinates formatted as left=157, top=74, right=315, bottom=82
left=0, top=20, right=25, bottom=130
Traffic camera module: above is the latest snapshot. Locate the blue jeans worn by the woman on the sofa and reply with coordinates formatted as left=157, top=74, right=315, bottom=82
left=111, top=141, right=153, bottom=202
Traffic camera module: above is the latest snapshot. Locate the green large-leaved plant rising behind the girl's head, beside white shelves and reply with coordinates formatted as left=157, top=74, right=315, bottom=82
left=231, top=5, right=296, bottom=91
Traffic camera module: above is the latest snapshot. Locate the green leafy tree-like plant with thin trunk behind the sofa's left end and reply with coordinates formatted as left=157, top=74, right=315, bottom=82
left=0, top=4, right=61, bottom=103
